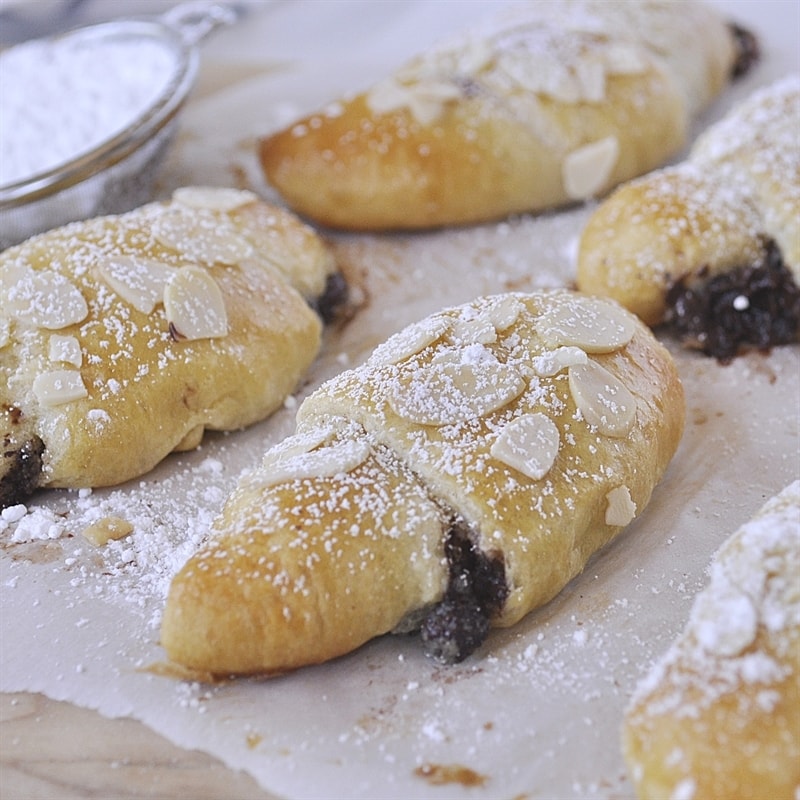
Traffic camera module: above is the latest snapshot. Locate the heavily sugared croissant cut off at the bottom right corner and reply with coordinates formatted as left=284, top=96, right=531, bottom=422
left=623, top=481, right=800, bottom=800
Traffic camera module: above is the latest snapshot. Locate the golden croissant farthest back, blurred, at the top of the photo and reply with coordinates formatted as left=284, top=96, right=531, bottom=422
left=259, top=0, right=751, bottom=230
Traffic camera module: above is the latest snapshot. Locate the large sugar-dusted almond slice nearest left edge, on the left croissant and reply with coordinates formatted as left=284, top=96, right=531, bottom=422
left=2, top=267, right=89, bottom=331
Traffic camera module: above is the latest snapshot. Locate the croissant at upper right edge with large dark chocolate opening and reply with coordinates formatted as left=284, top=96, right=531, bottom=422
left=577, top=75, right=800, bottom=360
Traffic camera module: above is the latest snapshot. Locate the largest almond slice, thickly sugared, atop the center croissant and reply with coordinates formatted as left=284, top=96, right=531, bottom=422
left=388, top=345, right=526, bottom=426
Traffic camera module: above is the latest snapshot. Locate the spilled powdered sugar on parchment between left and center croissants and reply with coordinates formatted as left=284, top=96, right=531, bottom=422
left=0, top=441, right=247, bottom=627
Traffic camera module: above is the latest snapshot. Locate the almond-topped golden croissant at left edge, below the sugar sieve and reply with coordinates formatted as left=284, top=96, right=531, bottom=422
left=0, top=187, right=335, bottom=505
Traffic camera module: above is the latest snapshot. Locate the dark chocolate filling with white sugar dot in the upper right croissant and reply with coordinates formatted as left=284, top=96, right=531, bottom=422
left=666, top=242, right=800, bottom=363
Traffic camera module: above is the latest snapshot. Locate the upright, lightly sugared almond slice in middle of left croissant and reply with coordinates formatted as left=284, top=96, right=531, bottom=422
left=164, top=267, right=228, bottom=339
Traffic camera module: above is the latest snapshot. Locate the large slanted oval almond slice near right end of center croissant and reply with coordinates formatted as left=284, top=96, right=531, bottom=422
left=568, top=361, right=636, bottom=437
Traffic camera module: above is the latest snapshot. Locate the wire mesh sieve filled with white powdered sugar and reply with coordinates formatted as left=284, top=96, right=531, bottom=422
left=0, top=2, right=236, bottom=249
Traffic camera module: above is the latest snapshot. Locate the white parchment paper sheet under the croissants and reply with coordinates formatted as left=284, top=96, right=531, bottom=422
left=0, top=0, right=800, bottom=800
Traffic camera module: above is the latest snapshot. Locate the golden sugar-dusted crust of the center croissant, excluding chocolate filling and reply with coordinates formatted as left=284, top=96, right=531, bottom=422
left=161, top=292, right=684, bottom=675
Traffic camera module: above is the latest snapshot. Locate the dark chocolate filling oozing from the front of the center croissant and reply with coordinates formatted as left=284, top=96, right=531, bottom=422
left=420, top=521, right=508, bottom=664
